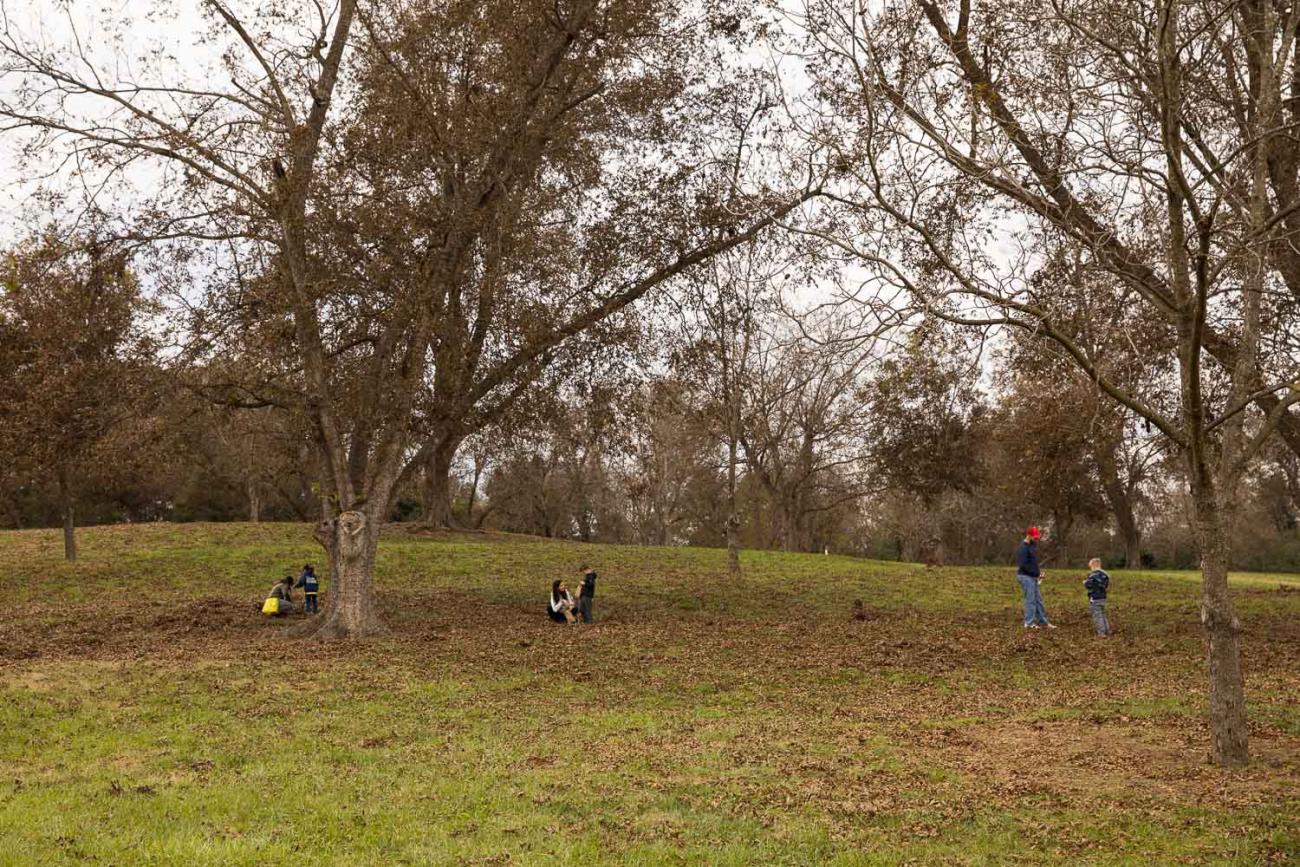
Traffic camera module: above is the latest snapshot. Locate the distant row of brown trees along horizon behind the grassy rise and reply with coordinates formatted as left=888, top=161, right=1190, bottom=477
left=0, top=259, right=1300, bottom=572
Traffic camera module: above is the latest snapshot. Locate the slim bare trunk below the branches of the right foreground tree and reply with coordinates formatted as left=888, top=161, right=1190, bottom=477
left=1192, top=490, right=1249, bottom=767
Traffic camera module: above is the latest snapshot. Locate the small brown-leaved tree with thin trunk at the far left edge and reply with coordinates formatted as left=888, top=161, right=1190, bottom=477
left=0, top=234, right=156, bottom=560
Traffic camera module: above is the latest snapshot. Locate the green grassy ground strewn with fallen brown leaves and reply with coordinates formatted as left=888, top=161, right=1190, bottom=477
left=0, top=525, right=1300, bottom=864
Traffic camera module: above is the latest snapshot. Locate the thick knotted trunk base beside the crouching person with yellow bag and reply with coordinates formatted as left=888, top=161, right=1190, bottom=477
left=312, top=511, right=386, bottom=640
